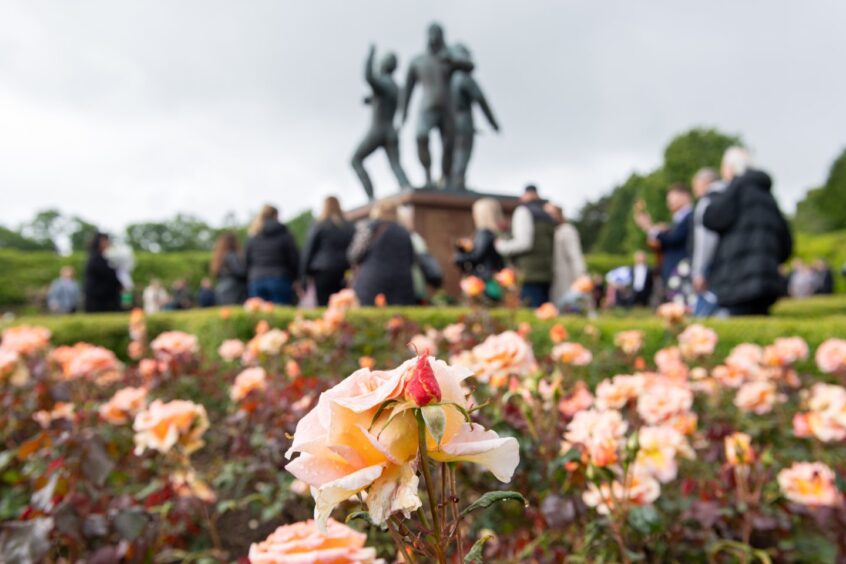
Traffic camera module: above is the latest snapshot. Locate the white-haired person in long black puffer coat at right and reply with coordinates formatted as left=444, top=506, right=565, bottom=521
left=703, top=147, right=793, bottom=315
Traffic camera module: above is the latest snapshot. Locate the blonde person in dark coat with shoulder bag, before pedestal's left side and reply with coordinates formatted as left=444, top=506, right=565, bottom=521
left=347, top=202, right=417, bottom=305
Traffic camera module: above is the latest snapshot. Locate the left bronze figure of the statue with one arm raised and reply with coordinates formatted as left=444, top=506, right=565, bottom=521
left=352, top=46, right=409, bottom=201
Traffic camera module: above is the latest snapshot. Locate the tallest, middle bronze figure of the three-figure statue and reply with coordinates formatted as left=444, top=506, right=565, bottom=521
left=402, top=23, right=464, bottom=185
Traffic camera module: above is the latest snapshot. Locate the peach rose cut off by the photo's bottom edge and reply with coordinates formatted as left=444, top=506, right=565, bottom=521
left=249, top=519, right=382, bottom=564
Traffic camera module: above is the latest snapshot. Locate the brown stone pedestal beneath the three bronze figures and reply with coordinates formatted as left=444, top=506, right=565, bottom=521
left=347, top=189, right=518, bottom=298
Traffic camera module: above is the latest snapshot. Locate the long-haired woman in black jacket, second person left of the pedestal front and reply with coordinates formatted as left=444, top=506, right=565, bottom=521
left=300, top=196, right=353, bottom=306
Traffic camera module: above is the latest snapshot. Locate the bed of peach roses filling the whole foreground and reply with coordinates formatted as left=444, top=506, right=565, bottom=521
left=0, top=296, right=846, bottom=562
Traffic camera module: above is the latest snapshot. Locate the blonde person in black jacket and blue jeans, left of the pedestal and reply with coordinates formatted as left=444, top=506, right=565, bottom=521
left=246, top=205, right=300, bottom=305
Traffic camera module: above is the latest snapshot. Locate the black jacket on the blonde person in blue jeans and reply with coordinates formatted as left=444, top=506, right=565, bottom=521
left=245, top=219, right=300, bottom=281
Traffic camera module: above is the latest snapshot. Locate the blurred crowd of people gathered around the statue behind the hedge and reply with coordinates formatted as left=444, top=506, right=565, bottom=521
left=47, top=147, right=834, bottom=316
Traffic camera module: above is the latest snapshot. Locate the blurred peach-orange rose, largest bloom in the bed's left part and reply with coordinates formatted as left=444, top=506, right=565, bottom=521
left=132, top=400, right=209, bottom=455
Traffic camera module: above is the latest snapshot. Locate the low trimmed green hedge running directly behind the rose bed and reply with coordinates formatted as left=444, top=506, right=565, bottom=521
left=6, top=296, right=846, bottom=362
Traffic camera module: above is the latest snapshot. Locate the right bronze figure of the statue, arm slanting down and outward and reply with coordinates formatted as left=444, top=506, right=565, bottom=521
left=449, top=44, right=499, bottom=190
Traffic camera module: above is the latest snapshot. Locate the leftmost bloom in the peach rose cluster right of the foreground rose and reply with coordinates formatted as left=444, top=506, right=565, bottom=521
left=564, top=409, right=628, bottom=466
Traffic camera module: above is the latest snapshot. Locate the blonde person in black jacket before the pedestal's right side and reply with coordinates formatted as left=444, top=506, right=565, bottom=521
left=453, top=198, right=505, bottom=288
